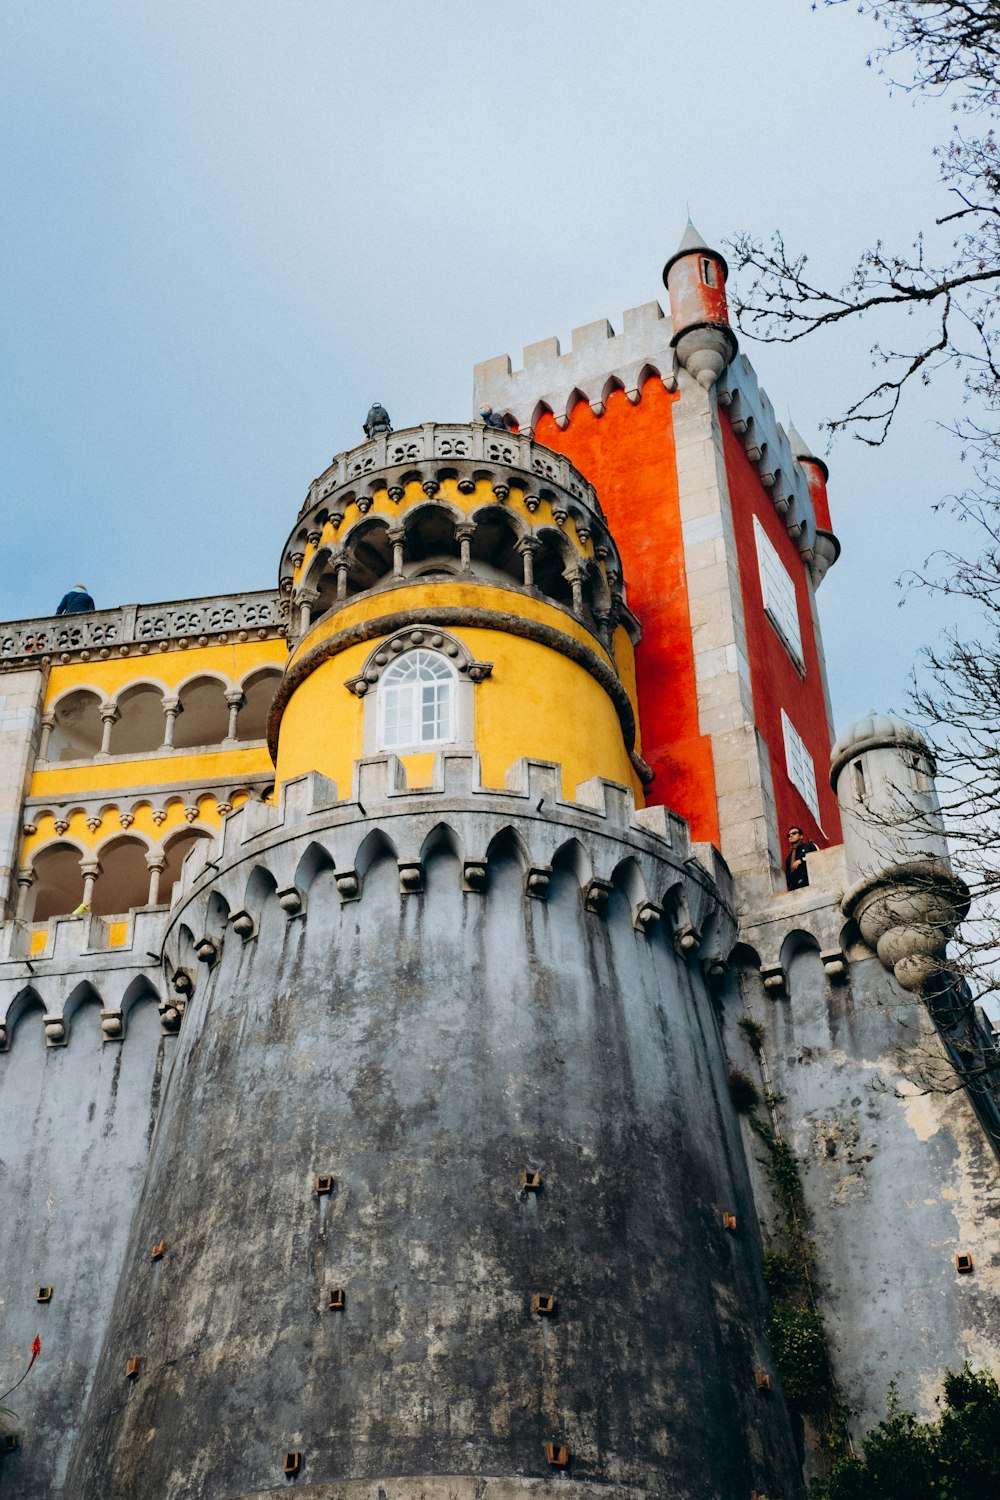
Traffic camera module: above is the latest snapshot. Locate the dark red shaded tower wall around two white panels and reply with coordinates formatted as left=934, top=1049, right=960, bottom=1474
left=720, top=411, right=841, bottom=846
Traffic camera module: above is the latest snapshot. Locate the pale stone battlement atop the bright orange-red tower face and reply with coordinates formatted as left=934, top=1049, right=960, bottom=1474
left=472, top=302, right=676, bottom=434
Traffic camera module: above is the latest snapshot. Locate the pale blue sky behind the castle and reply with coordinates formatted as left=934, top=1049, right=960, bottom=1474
left=0, top=0, right=961, bottom=726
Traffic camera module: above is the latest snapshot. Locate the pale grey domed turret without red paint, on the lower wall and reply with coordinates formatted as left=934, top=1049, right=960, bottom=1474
left=831, top=713, right=969, bottom=990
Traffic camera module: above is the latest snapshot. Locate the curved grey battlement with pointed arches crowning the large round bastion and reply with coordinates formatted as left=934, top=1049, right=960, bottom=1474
left=166, top=752, right=735, bottom=984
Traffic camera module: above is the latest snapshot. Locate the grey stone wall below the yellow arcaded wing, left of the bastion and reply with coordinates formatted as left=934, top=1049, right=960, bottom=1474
left=0, top=975, right=174, bottom=1500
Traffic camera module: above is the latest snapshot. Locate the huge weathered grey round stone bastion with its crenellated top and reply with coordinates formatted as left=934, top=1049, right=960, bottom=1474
left=69, top=758, right=801, bottom=1500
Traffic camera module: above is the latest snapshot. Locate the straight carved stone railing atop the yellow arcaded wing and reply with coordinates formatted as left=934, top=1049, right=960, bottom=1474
left=0, top=590, right=288, bottom=666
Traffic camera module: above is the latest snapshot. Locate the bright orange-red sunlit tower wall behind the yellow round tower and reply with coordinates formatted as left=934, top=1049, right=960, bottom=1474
left=535, top=378, right=718, bottom=845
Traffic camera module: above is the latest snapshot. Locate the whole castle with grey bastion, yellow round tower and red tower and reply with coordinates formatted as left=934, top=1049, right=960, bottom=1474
left=0, top=225, right=1000, bottom=1500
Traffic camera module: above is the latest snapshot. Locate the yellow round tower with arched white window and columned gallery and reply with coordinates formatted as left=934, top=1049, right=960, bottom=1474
left=268, top=423, right=651, bottom=804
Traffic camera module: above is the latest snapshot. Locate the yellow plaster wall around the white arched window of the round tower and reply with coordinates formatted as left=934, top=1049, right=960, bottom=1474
left=277, top=582, right=642, bottom=806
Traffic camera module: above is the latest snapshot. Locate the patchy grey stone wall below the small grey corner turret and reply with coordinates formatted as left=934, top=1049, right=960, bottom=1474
left=726, top=876, right=1000, bottom=1434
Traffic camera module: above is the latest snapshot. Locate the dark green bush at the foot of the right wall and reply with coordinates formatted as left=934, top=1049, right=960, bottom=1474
left=810, top=1365, right=1000, bottom=1500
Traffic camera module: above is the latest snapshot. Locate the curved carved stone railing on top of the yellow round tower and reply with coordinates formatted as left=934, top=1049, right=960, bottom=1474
left=300, top=422, right=603, bottom=519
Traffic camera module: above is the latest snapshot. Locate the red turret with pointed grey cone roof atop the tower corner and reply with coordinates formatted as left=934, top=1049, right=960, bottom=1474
left=663, top=219, right=738, bottom=390
